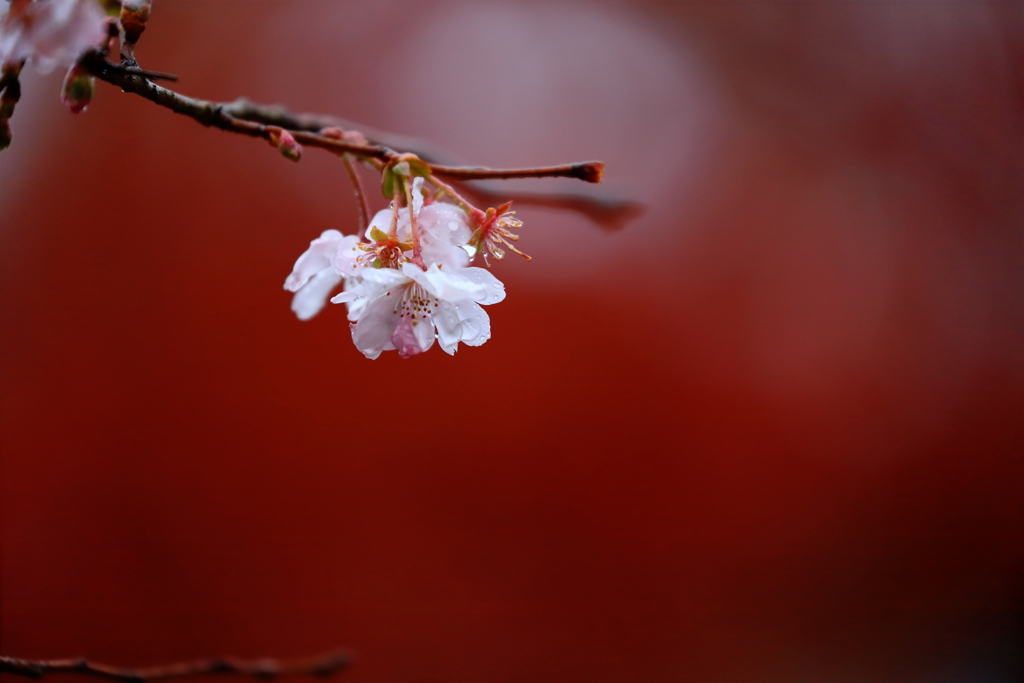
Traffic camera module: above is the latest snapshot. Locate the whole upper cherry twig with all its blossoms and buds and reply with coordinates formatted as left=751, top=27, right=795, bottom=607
left=0, top=0, right=604, bottom=358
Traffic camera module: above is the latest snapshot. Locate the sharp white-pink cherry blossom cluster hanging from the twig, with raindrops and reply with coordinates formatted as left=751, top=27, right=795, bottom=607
left=285, top=155, right=529, bottom=358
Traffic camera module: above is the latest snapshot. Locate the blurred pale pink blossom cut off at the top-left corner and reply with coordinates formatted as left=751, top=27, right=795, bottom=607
left=0, top=0, right=105, bottom=73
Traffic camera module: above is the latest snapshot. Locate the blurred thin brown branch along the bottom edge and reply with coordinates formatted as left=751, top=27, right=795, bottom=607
left=0, top=652, right=351, bottom=683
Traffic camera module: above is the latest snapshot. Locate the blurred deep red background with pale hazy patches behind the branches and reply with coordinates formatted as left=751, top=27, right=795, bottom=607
left=0, top=0, right=1024, bottom=683
